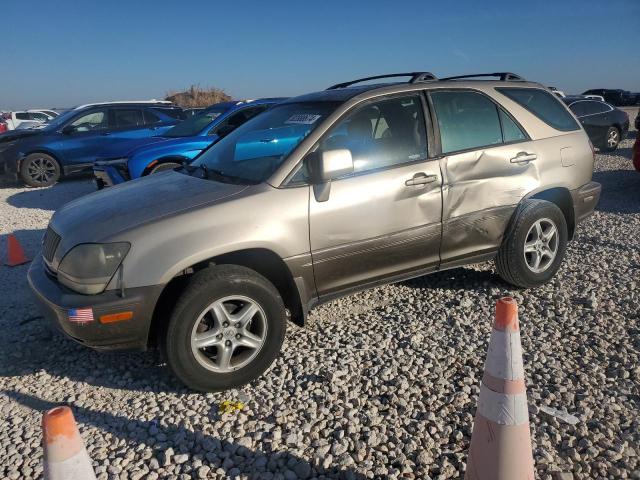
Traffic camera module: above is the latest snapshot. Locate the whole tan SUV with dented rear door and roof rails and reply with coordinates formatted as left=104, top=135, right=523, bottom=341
left=29, top=72, right=600, bottom=391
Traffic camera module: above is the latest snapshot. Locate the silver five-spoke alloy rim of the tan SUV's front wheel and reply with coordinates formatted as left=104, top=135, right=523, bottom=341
left=191, top=295, right=267, bottom=373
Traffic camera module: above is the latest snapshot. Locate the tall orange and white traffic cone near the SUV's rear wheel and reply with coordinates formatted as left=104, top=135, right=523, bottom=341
left=465, top=297, right=534, bottom=480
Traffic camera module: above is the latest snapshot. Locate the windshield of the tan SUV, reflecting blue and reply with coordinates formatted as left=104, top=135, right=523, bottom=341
left=192, top=102, right=340, bottom=183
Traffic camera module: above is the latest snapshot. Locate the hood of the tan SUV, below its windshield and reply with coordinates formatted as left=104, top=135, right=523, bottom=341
left=50, top=171, right=247, bottom=248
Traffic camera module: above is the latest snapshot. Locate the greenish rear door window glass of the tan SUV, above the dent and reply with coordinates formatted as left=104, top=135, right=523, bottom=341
left=430, top=90, right=527, bottom=153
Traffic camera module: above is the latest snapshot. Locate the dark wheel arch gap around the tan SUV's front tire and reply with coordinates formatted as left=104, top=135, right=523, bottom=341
left=147, top=248, right=305, bottom=343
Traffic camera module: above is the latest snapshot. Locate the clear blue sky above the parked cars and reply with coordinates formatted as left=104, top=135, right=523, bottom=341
left=0, top=0, right=640, bottom=110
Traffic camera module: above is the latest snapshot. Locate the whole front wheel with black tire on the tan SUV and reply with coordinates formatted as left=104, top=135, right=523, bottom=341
left=164, top=265, right=286, bottom=392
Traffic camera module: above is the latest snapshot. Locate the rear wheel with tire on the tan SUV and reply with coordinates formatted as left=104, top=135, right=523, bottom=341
left=496, top=200, right=567, bottom=288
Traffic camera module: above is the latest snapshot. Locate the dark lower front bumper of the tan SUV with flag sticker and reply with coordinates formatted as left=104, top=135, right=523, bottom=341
left=27, top=256, right=162, bottom=350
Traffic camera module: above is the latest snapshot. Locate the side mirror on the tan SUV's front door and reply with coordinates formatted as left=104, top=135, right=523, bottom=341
left=307, top=148, right=353, bottom=202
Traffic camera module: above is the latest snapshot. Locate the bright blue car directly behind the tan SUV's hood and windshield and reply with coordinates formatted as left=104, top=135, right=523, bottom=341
left=93, top=98, right=284, bottom=189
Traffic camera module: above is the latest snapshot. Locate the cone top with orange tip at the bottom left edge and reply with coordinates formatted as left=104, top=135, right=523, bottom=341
left=42, top=407, right=96, bottom=480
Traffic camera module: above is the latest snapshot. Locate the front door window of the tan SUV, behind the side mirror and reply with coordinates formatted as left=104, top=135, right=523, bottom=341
left=318, top=95, right=427, bottom=173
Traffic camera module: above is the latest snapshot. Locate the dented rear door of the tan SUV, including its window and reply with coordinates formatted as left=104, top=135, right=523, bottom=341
left=429, top=89, right=540, bottom=268
